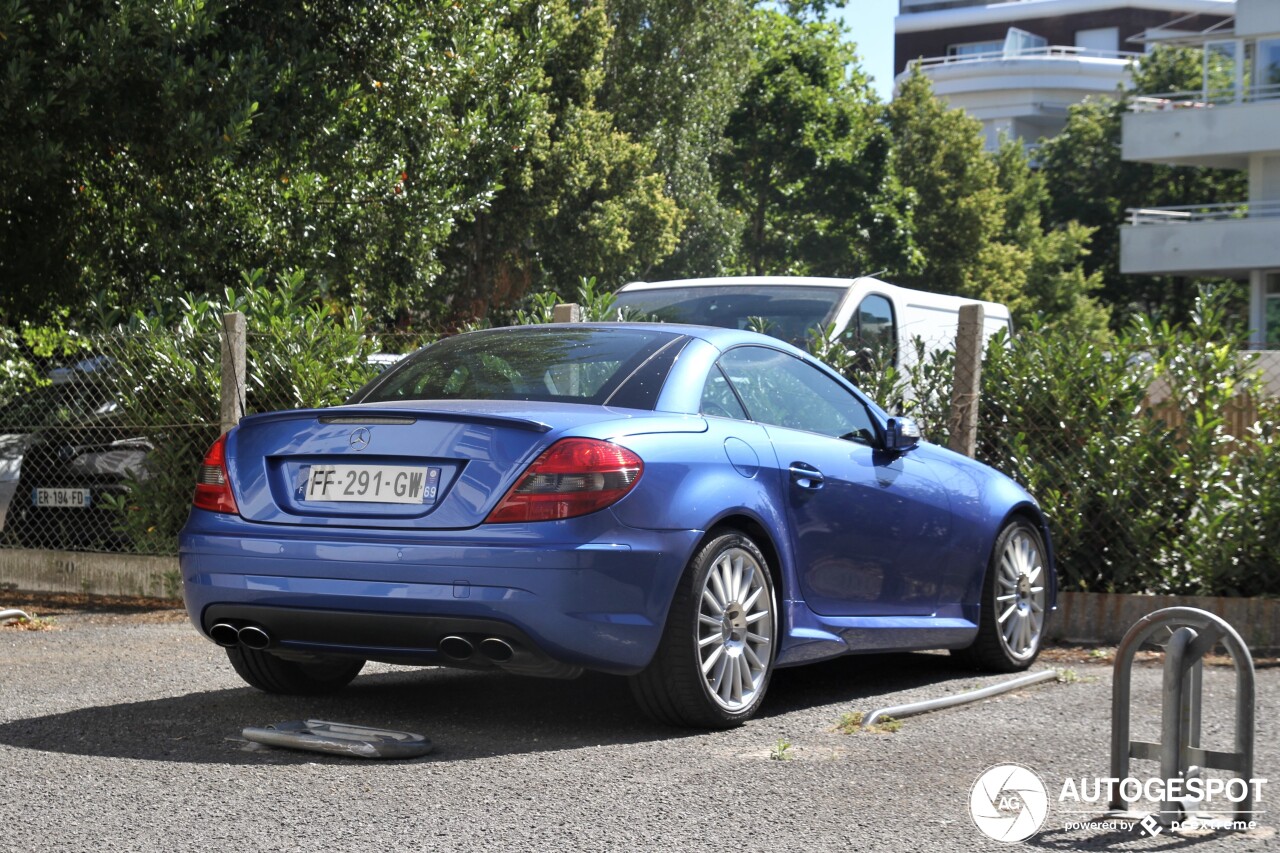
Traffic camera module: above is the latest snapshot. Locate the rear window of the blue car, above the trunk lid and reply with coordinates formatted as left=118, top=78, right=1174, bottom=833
left=348, top=328, right=686, bottom=409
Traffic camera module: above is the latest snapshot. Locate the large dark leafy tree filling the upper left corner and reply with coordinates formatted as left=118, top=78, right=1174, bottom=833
left=0, top=0, right=541, bottom=320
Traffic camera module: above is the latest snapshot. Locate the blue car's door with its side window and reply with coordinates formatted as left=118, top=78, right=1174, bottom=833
left=721, top=346, right=951, bottom=616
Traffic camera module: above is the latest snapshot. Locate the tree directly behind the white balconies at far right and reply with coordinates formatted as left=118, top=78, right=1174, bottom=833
left=1038, top=46, right=1247, bottom=321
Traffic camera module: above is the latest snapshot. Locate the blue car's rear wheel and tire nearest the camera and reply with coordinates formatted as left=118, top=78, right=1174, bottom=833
left=631, top=532, right=778, bottom=729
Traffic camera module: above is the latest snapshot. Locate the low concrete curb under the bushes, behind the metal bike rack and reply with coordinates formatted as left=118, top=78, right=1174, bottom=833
left=1048, top=592, right=1280, bottom=654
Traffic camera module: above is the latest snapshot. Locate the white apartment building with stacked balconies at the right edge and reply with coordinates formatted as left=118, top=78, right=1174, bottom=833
left=1120, top=0, right=1280, bottom=350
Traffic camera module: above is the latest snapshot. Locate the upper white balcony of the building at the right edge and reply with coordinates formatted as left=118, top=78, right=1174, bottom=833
left=1121, top=86, right=1280, bottom=169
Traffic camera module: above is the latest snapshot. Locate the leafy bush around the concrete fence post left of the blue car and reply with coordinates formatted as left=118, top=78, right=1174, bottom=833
left=104, top=270, right=378, bottom=553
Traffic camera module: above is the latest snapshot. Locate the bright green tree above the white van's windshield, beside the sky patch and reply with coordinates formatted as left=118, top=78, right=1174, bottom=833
left=716, top=10, right=915, bottom=275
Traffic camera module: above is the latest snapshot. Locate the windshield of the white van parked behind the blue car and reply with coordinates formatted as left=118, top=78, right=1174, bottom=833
left=616, top=284, right=847, bottom=347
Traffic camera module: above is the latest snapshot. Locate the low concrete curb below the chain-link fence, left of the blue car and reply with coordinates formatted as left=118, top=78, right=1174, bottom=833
left=0, top=548, right=182, bottom=601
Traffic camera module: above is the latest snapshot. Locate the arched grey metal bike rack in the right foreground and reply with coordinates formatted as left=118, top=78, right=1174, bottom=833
left=1111, top=607, right=1256, bottom=825
